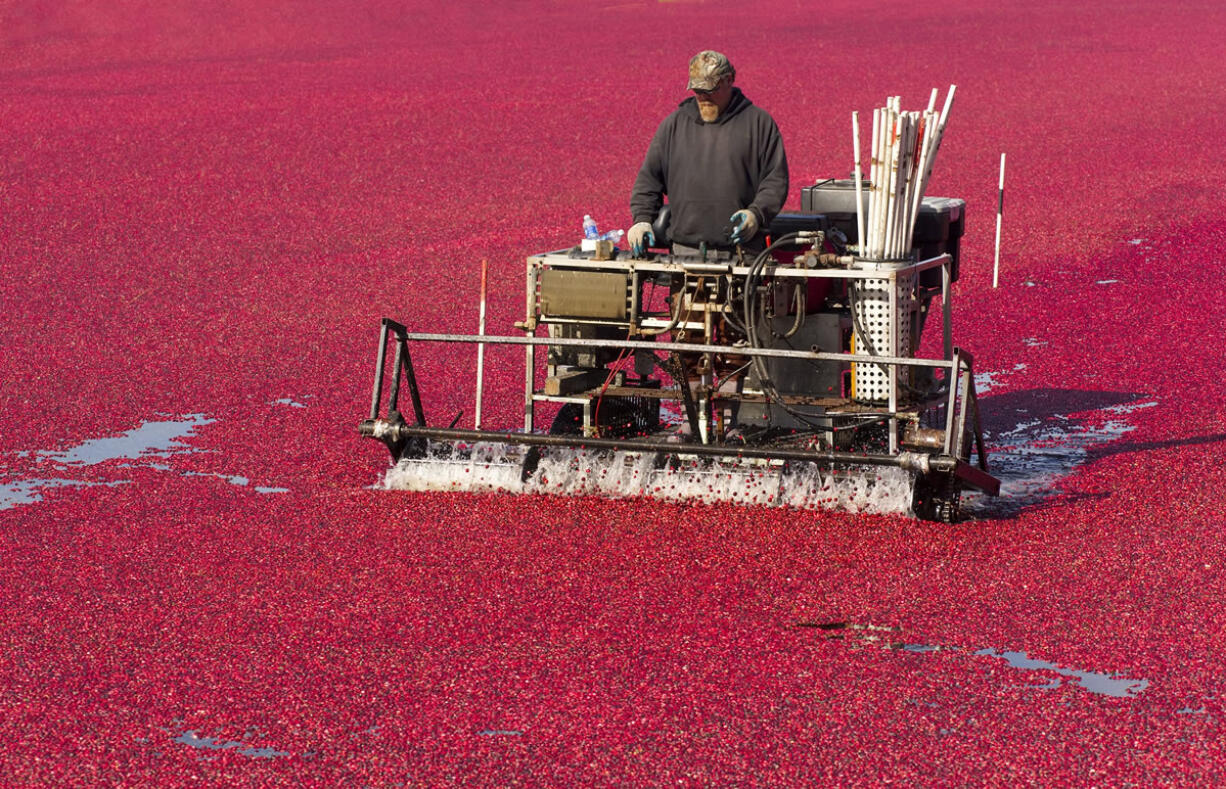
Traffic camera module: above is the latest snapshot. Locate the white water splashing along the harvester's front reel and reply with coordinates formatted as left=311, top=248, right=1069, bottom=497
left=384, top=444, right=915, bottom=513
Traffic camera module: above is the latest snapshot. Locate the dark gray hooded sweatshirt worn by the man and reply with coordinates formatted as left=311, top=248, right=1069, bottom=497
left=630, top=88, right=788, bottom=247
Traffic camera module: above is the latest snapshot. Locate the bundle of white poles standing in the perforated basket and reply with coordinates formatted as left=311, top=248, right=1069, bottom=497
left=851, top=85, right=955, bottom=260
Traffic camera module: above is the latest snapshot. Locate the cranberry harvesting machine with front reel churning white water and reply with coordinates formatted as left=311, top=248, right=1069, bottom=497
left=359, top=181, right=999, bottom=522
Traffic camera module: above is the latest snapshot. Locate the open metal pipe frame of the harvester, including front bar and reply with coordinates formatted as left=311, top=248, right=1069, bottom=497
left=359, top=243, right=999, bottom=521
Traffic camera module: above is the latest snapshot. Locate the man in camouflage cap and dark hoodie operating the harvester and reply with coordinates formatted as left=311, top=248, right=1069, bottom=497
left=628, top=49, right=787, bottom=257
